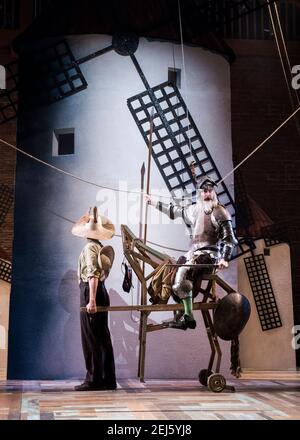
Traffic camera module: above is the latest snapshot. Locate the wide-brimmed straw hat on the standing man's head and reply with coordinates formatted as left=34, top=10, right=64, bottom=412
left=72, top=206, right=115, bottom=240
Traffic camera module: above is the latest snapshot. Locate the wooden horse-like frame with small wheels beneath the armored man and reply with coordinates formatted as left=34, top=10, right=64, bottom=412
left=81, top=225, right=235, bottom=392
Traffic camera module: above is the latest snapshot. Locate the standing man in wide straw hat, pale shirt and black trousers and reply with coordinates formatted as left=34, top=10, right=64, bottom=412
left=72, top=207, right=117, bottom=391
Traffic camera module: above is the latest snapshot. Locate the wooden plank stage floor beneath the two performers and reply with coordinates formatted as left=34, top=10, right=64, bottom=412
left=0, top=373, right=300, bottom=420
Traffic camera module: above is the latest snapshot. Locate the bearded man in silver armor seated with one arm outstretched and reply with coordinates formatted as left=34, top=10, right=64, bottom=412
left=145, top=177, right=237, bottom=330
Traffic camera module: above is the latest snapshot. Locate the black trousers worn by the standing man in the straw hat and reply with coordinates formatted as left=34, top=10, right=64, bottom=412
left=80, top=281, right=116, bottom=385
